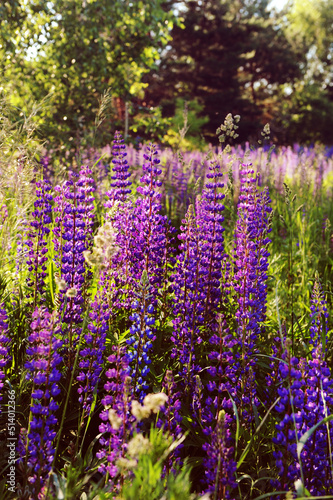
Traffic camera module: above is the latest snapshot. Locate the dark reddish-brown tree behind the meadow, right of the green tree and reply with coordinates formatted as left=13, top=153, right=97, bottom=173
left=146, top=0, right=302, bottom=144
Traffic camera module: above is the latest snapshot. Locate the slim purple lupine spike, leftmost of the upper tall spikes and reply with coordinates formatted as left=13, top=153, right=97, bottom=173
left=26, top=181, right=53, bottom=308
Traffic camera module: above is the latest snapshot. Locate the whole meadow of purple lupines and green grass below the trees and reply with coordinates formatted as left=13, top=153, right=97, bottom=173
left=0, top=115, right=333, bottom=500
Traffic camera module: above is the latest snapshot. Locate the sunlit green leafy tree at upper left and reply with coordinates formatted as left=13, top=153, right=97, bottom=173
left=0, top=0, right=173, bottom=148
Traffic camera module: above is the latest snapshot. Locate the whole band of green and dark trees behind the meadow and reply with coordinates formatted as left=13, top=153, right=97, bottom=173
left=0, top=0, right=333, bottom=150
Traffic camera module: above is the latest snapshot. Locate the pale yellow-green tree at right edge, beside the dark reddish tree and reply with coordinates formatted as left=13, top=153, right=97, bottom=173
left=275, top=0, right=333, bottom=144
